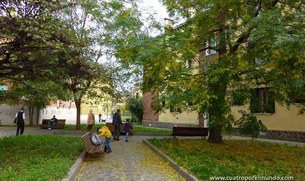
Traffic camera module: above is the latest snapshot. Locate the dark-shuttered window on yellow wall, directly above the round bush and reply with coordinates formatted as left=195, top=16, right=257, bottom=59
left=250, top=88, right=275, bottom=113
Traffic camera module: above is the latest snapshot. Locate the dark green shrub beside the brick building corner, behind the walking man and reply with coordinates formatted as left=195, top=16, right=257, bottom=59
left=126, top=96, right=143, bottom=122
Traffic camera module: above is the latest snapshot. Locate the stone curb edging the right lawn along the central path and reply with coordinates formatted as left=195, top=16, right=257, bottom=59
left=142, top=139, right=198, bottom=181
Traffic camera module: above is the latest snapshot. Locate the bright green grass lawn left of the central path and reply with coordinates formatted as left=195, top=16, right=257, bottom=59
left=0, top=135, right=83, bottom=181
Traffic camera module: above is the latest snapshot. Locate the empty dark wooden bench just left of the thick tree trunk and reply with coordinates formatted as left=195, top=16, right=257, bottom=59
left=171, top=127, right=209, bottom=139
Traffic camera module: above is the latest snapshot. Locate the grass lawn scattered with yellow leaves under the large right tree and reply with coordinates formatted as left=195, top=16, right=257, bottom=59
left=149, top=138, right=305, bottom=180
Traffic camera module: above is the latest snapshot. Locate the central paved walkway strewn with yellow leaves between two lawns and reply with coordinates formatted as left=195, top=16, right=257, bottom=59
left=75, top=136, right=184, bottom=181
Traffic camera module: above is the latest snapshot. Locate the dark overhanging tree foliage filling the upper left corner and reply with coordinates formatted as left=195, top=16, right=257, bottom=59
left=0, top=0, right=69, bottom=80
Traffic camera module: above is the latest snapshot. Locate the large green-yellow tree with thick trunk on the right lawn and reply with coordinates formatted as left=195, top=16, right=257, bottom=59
left=114, top=0, right=305, bottom=143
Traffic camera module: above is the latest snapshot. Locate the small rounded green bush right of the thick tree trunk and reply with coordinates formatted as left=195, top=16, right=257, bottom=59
left=235, top=111, right=267, bottom=138
